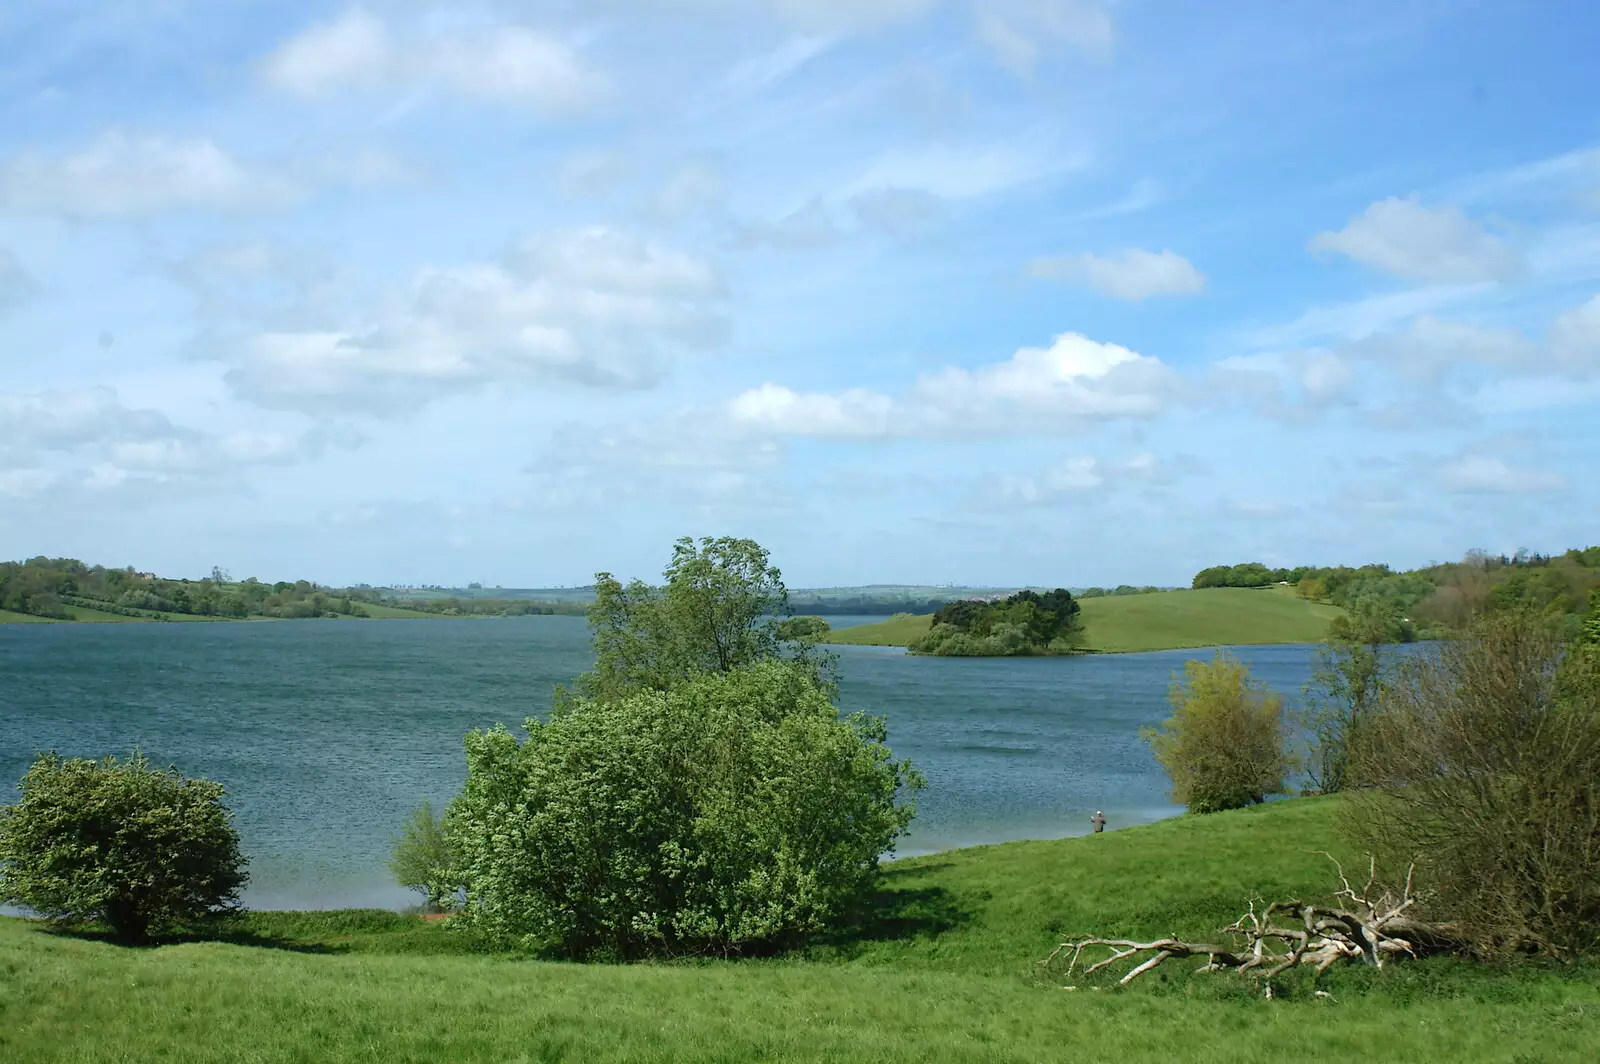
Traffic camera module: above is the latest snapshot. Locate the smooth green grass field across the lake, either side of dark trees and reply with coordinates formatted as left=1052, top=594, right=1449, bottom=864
left=826, top=587, right=1341, bottom=653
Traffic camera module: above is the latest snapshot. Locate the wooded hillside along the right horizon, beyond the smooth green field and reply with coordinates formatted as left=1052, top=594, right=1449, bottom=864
left=1192, top=546, right=1600, bottom=638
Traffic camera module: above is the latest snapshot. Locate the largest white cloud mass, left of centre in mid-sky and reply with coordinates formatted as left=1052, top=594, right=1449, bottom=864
left=213, top=227, right=723, bottom=411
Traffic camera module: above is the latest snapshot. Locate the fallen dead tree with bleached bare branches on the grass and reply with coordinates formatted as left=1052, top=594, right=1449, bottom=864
left=1040, top=851, right=1461, bottom=995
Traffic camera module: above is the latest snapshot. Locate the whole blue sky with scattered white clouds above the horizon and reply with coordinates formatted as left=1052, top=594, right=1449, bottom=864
left=0, top=0, right=1600, bottom=587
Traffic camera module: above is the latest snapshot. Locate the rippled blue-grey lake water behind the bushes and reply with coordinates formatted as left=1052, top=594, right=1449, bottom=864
left=0, top=618, right=1310, bottom=909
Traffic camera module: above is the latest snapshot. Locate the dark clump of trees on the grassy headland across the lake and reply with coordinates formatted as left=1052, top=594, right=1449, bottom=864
left=910, top=587, right=1083, bottom=658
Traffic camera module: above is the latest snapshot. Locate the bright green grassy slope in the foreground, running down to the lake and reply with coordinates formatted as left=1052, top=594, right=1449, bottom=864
left=0, top=800, right=1600, bottom=1064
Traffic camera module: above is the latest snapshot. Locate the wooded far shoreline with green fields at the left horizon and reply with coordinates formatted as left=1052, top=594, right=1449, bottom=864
left=0, top=555, right=586, bottom=621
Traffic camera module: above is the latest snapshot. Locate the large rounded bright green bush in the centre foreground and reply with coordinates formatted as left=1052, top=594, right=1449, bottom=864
left=448, top=659, right=922, bottom=958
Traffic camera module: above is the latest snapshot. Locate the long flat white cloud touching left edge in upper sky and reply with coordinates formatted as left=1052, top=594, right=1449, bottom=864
left=0, top=131, right=304, bottom=218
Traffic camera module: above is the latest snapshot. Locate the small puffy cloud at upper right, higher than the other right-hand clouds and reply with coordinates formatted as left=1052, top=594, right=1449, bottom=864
left=1310, top=197, right=1523, bottom=283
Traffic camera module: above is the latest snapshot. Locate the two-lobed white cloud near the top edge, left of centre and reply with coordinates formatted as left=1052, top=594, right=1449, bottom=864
left=262, top=10, right=602, bottom=114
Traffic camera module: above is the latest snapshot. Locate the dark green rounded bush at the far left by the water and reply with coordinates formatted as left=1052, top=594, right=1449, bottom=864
left=0, top=754, right=246, bottom=942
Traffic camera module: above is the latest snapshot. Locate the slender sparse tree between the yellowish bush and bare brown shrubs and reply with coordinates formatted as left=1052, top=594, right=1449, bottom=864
left=1306, top=598, right=1405, bottom=794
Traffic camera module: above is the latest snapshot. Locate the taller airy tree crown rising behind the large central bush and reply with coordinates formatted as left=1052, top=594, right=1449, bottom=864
left=578, top=538, right=832, bottom=699
